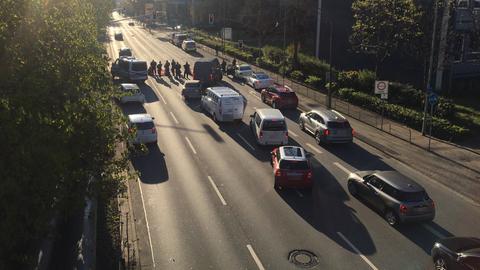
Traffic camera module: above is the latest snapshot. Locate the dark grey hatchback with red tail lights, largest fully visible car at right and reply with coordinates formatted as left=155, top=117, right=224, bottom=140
left=347, top=171, right=435, bottom=226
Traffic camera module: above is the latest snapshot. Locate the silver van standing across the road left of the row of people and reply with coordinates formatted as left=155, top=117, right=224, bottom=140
left=110, top=56, right=148, bottom=82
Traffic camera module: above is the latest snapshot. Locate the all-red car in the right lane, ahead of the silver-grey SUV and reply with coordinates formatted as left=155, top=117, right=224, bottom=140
left=262, top=84, right=298, bottom=109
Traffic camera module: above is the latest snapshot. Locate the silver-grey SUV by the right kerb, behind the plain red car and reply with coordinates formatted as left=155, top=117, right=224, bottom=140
left=298, top=108, right=355, bottom=144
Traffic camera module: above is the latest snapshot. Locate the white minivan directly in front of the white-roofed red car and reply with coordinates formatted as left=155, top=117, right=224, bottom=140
left=250, top=109, right=288, bottom=145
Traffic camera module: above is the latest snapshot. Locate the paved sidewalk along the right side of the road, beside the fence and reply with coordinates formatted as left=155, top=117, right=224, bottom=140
left=191, top=40, right=480, bottom=203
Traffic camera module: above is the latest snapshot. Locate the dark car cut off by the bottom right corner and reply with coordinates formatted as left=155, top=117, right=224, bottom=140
left=431, top=237, right=480, bottom=270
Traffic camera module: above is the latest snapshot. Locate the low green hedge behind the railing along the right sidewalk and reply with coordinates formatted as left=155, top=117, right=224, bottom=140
left=338, top=88, right=470, bottom=140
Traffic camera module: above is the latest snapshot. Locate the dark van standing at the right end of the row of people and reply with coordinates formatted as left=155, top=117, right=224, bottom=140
left=193, top=58, right=222, bottom=88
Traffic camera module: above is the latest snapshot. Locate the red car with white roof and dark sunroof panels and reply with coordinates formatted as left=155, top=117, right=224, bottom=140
left=271, top=146, right=313, bottom=188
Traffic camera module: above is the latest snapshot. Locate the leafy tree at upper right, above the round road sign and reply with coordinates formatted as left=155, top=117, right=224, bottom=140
left=350, top=0, right=423, bottom=74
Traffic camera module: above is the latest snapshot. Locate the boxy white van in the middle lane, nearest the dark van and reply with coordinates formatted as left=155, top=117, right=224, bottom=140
left=201, top=87, right=245, bottom=122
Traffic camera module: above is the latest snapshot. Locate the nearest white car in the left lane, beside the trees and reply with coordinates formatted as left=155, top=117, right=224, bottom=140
left=128, top=113, right=157, bottom=144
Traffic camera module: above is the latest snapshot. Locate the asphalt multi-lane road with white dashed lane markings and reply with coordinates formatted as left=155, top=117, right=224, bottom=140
left=108, top=14, right=480, bottom=270
